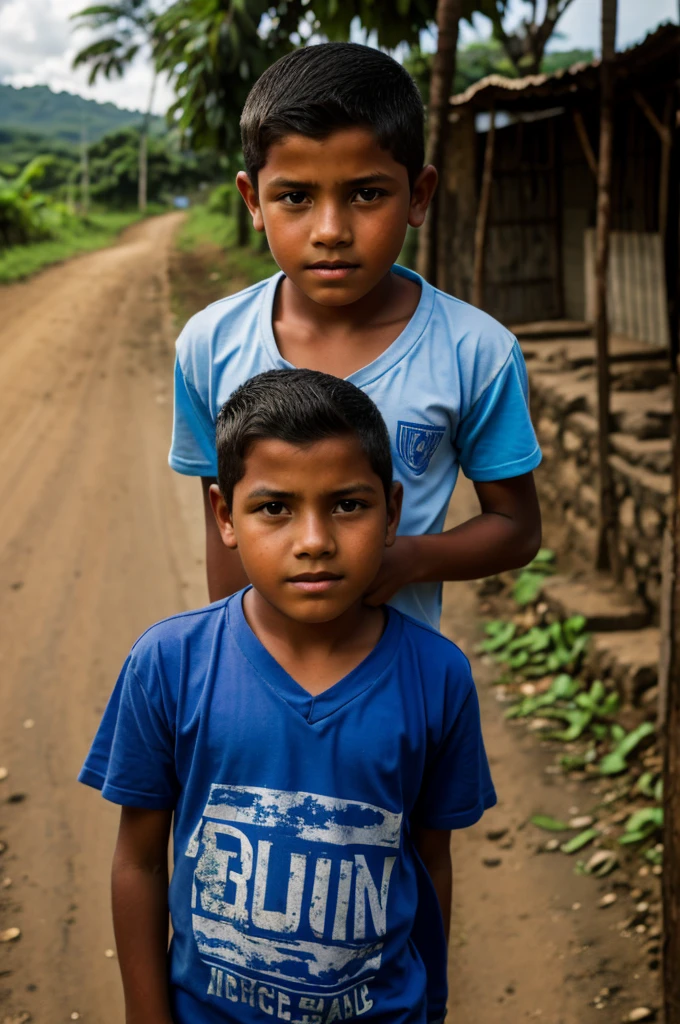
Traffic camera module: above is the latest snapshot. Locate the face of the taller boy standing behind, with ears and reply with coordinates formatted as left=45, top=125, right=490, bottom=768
left=237, top=127, right=436, bottom=306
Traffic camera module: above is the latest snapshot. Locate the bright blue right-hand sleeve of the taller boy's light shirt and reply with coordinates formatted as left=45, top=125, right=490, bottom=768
left=455, top=341, right=541, bottom=481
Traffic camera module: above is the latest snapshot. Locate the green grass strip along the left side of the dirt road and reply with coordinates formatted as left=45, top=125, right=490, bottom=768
left=0, top=210, right=159, bottom=285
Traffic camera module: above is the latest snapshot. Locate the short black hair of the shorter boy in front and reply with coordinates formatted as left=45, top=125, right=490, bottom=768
left=215, top=370, right=392, bottom=507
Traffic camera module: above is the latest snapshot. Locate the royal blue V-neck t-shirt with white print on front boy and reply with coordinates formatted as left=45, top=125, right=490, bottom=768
left=80, top=591, right=496, bottom=1024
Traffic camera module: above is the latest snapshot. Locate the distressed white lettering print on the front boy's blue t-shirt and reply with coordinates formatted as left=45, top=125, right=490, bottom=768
left=186, top=784, right=401, bottom=1024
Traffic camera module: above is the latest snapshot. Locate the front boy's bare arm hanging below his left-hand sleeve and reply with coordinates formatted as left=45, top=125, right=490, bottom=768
left=112, top=807, right=172, bottom=1024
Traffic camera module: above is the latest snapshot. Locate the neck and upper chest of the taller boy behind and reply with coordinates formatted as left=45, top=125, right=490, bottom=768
left=272, top=270, right=421, bottom=377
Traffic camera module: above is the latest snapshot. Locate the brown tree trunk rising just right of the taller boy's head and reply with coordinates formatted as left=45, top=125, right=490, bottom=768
left=417, top=0, right=463, bottom=285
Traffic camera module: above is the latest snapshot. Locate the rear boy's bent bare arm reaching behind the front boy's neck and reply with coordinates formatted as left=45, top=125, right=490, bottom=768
left=366, top=473, right=541, bottom=605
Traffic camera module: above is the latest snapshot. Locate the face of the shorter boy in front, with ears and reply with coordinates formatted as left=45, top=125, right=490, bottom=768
left=211, top=436, right=401, bottom=624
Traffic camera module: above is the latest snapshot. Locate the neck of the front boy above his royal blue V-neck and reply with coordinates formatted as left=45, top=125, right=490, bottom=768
left=244, top=588, right=385, bottom=695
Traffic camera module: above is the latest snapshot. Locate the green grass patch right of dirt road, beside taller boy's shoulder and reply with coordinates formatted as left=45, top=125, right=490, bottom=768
left=176, top=199, right=279, bottom=285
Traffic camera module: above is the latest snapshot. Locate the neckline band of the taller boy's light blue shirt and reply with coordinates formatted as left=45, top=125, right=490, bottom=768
left=259, top=263, right=436, bottom=388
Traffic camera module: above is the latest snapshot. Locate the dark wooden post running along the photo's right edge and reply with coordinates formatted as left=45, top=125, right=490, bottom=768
left=660, top=39, right=680, bottom=1024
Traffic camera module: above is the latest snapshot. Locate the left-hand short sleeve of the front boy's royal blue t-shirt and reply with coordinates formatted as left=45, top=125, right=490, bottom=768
left=78, top=657, right=179, bottom=810
